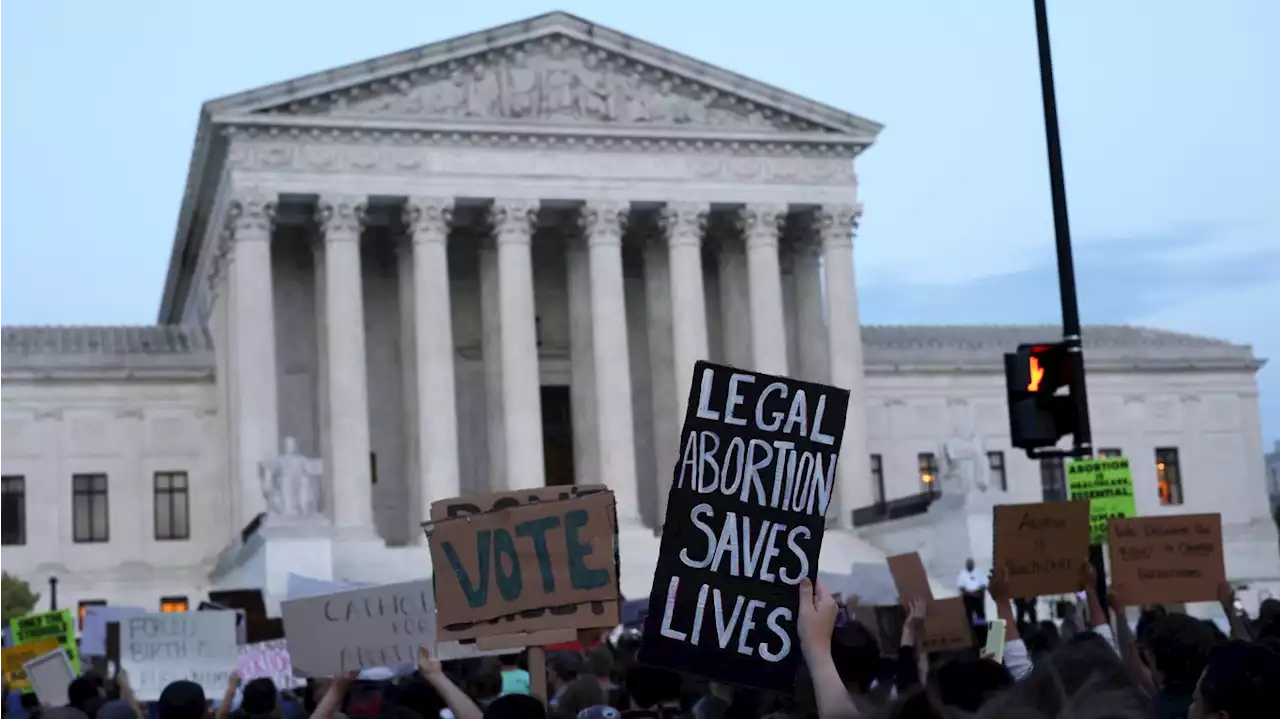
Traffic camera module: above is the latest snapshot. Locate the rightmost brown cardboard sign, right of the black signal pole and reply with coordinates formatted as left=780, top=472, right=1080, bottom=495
left=1108, top=514, right=1226, bottom=606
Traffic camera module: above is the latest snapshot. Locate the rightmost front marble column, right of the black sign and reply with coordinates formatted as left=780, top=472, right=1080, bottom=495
left=817, top=205, right=874, bottom=528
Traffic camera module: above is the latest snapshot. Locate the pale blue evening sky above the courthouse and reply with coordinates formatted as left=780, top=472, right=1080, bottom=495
left=0, top=0, right=1280, bottom=444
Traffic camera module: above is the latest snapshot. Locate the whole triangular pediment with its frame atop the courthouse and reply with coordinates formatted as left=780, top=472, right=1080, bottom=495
left=209, top=13, right=881, bottom=138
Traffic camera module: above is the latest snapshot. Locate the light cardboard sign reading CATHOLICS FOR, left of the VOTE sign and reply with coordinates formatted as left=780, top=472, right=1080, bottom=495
left=280, top=580, right=435, bottom=678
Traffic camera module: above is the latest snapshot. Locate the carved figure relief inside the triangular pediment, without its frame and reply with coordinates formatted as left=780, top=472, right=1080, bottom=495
left=274, top=36, right=829, bottom=132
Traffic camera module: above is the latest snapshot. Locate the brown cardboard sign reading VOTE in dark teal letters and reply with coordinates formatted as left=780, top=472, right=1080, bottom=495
left=429, top=490, right=618, bottom=638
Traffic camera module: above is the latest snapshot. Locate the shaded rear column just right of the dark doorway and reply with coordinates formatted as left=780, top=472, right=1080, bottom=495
left=564, top=228, right=602, bottom=485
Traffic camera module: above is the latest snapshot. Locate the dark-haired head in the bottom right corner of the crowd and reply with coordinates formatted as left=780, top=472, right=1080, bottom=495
left=1187, top=641, right=1280, bottom=719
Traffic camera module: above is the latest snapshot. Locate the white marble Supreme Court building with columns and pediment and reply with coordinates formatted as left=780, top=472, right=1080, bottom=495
left=0, top=13, right=1280, bottom=606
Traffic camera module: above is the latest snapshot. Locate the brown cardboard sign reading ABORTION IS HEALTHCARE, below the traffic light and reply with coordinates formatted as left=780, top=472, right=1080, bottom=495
left=995, top=502, right=1089, bottom=596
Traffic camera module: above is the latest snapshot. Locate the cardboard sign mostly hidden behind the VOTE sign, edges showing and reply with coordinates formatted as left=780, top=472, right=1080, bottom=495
left=424, top=486, right=621, bottom=639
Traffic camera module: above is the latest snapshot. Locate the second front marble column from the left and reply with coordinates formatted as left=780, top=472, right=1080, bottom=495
left=316, top=196, right=374, bottom=532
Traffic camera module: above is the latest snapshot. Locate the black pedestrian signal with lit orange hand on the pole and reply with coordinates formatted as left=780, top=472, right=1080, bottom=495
left=1005, top=343, right=1079, bottom=453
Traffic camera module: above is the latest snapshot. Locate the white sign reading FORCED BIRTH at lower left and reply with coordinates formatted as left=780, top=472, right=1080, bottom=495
left=119, top=612, right=239, bottom=701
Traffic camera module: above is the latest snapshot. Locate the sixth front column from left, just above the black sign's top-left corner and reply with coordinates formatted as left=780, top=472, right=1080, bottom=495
left=660, top=202, right=709, bottom=426
